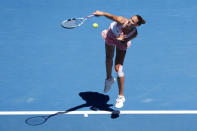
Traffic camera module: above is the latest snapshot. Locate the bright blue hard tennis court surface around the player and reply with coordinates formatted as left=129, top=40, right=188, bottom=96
left=0, top=0, right=197, bottom=131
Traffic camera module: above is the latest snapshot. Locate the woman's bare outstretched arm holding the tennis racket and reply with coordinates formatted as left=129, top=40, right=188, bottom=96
left=93, top=10, right=128, bottom=24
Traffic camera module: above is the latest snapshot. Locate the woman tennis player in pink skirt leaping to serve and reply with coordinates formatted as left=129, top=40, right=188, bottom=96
left=93, top=10, right=146, bottom=108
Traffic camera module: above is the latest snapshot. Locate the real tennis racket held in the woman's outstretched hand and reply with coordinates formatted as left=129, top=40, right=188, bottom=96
left=61, top=15, right=94, bottom=29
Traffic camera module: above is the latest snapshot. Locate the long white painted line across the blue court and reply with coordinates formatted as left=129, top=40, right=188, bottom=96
left=0, top=110, right=197, bottom=115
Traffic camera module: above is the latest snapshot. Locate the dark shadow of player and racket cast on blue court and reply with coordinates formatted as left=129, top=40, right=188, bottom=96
left=25, top=92, right=120, bottom=126
